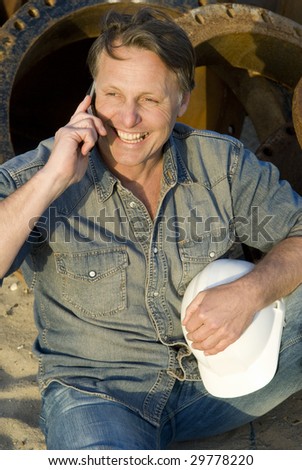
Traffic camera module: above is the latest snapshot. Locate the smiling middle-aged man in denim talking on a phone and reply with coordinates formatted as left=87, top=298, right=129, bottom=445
left=0, top=8, right=302, bottom=449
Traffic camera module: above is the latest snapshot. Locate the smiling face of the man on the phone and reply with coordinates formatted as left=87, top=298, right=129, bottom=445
left=95, top=47, right=189, bottom=175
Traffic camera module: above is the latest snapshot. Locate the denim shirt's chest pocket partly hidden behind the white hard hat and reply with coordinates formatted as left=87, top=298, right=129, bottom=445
left=178, top=231, right=232, bottom=295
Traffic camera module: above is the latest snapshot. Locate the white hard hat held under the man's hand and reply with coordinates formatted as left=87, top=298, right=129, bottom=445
left=181, top=259, right=285, bottom=398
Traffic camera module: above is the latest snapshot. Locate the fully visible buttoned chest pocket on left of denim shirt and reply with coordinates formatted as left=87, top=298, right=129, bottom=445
left=55, top=247, right=128, bottom=319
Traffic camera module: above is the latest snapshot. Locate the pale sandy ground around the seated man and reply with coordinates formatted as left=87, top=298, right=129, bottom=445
left=0, top=275, right=302, bottom=450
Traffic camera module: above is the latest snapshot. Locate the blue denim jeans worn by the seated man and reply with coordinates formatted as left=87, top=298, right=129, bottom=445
left=41, top=296, right=302, bottom=450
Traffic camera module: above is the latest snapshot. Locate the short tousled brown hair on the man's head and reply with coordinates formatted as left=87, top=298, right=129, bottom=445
left=87, top=7, right=195, bottom=93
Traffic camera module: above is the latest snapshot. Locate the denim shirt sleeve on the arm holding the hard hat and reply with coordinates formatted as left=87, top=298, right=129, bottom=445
left=231, top=149, right=302, bottom=252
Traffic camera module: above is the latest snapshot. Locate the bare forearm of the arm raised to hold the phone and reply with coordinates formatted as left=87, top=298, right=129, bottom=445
left=0, top=169, right=65, bottom=278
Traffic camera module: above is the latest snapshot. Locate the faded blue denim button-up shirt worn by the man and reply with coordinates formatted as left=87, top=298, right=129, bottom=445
left=0, top=124, right=302, bottom=425
